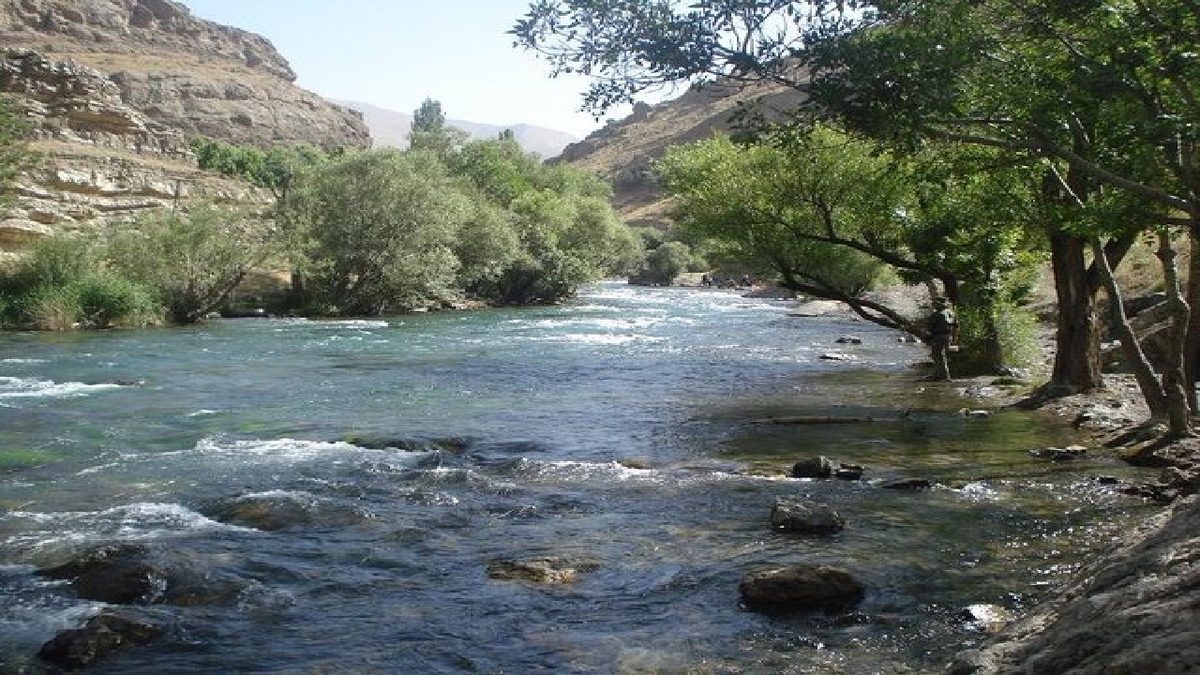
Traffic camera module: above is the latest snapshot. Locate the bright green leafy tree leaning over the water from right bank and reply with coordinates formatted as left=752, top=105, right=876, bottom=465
left=658, top=127, right=1034, bottom=372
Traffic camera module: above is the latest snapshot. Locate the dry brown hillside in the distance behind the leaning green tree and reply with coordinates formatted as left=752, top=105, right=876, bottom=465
left=554, top=82, right=800, bottom=227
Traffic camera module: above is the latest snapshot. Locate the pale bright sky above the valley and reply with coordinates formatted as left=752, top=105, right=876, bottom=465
left=181, top=0, right=624, bottom=138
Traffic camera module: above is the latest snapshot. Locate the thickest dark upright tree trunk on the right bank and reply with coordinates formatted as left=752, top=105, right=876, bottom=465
left=1049, top=232, right=1104, bottom=395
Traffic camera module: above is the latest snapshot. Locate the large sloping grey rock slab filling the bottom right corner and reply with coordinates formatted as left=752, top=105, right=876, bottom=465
left=946, top=496, right=1200, bottom=675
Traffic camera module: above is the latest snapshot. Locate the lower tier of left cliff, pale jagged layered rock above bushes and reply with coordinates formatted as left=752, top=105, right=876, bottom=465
left=0, top=50, right=264, bottom=251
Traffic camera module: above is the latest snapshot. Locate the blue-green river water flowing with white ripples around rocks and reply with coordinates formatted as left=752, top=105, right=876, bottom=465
left=0, top=283, right=1156, bottom=675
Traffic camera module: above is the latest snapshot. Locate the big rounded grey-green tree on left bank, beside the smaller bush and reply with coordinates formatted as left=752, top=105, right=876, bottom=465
left=287, top=150, right=472, bottom=316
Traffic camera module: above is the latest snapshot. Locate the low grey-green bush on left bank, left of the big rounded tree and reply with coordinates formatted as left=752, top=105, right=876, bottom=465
left=107, top=204, right=280, bottom=324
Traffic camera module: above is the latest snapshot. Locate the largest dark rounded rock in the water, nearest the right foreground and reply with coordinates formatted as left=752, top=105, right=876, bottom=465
left=738, top=565, right=865, bottom=614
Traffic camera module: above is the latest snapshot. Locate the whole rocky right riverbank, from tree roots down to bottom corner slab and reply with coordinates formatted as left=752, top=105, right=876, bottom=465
left=946, top=375, right=1200, bottom=675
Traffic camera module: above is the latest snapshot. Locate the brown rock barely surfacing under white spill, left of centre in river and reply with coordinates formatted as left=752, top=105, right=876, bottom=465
left=199, top=491, right=367, bottom=532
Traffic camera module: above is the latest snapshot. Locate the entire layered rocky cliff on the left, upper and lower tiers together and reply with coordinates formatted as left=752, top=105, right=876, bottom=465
left=0, top=0, right=370, bottom=251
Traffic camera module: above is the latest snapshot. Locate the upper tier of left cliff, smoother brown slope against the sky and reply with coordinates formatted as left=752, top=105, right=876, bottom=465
left=0, top=0, right=370, bottom=148
